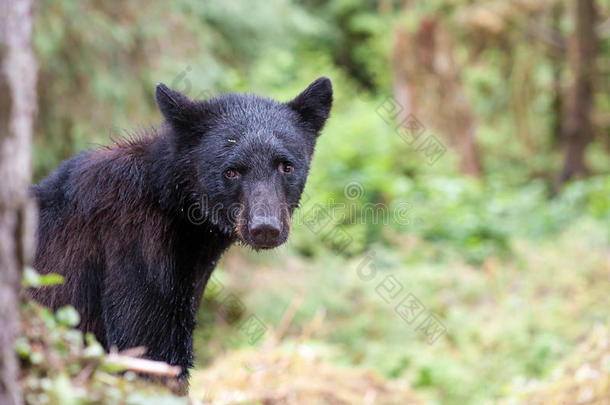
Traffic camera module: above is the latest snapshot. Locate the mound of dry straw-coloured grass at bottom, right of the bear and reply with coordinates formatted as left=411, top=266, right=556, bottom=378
left=191, top=344, right=424, bottom=405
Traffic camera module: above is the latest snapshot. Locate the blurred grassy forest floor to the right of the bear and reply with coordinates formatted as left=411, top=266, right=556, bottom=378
left=191, top=213, right=610, bottom=404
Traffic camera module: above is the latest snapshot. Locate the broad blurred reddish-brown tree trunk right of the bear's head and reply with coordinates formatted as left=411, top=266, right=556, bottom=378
left=392, top=17, right=481, bottom=177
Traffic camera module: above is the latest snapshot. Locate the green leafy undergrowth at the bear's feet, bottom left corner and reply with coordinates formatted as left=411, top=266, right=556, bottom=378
left=16, top=302, right=188, bottom=405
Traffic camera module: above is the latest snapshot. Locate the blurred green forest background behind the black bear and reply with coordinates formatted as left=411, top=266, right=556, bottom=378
left=26, top=0, right=610, bottom=404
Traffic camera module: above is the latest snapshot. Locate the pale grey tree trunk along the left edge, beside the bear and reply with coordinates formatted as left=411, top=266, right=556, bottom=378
left=0, top=0, right=36, bottom=405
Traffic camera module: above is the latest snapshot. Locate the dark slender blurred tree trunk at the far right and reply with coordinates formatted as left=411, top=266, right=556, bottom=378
left=560, top=0, right=597, bottom=183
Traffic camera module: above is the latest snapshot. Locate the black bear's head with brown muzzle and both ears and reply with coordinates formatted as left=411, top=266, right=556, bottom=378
left=155, top=77, right=333, bottom=249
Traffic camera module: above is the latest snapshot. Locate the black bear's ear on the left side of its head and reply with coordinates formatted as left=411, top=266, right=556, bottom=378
left=155, top=83, right=202, bottom=128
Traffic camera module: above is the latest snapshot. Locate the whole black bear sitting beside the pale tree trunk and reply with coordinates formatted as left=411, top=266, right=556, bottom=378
left=31, top=77, right=332, bottom=380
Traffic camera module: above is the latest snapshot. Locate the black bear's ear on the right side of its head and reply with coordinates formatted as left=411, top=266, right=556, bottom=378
left=288, top=77, right=333, bottom=132
